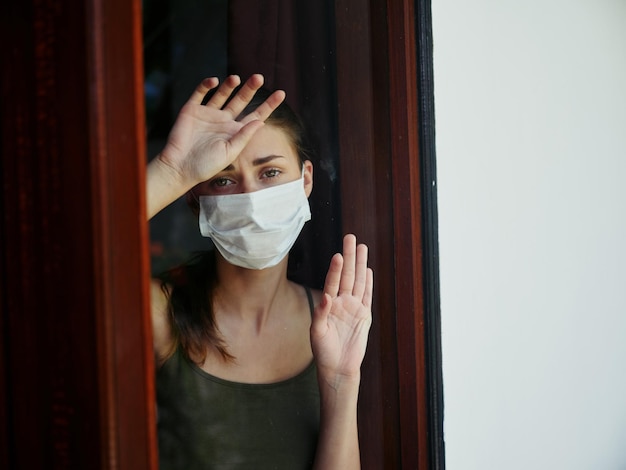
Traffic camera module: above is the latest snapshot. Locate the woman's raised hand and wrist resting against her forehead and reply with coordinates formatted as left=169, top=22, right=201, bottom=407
left=147, top=74, right=285, bottom=218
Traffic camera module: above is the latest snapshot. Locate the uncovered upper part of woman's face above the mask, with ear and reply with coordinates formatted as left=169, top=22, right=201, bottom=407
left=193, top=124, right=313, bottom=197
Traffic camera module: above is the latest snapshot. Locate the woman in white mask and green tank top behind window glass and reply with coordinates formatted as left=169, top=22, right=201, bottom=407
left=147, top=75, right=373, bottom=470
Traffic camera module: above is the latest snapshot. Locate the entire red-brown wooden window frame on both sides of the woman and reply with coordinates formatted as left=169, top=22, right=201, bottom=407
left=0, top=0, right=445, bottom=470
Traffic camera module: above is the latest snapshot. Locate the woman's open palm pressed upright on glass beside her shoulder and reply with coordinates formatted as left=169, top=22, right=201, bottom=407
left=311, top=235, right=373, bottom=387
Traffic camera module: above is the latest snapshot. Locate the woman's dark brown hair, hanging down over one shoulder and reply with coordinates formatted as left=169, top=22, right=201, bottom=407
left=159, top=88, right=312, bottom=365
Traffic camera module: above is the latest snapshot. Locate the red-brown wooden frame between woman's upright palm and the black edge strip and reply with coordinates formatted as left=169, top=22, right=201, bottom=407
left=336, top=0, right=430, bottom=469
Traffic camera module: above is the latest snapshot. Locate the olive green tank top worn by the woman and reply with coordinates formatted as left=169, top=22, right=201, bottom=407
left=156, top=290, right=320, bottom=470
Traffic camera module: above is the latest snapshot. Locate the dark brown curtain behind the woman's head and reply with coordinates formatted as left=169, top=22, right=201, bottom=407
left=228, top=0, right=342, bottom=287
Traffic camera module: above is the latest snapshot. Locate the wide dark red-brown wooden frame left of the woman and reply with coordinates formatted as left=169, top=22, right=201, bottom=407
left=0, top=0, right=156, bottom=469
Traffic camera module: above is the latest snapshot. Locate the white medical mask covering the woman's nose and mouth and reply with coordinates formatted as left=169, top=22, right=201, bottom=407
left=199, top=176, right=311, bottom=269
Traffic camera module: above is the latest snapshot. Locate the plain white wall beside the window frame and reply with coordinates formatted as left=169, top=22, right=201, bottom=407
left=432, top=0, right=626, bottom=470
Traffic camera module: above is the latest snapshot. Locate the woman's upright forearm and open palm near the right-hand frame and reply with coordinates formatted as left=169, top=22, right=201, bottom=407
left=311, top=235, right=373, bottom=470
